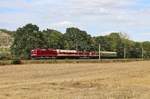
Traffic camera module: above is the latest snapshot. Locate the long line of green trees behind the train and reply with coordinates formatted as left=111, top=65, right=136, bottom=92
left=11, top=24, right=150, bottom=59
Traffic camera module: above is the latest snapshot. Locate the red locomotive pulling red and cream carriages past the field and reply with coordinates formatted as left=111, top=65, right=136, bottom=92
left=31, top=48, right=117, bottom=59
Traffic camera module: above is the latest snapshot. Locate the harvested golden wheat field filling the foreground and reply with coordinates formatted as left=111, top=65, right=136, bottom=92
left=0, top=61, right=150, bottom=99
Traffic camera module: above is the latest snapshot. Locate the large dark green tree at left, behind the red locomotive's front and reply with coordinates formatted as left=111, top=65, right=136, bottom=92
left=11, top=24, right=46, bottom=59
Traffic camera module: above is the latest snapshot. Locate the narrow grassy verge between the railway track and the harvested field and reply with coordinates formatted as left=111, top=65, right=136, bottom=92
left=0, top=59, right=148, bottom=65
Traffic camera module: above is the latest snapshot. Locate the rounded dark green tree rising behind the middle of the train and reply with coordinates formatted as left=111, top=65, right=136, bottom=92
left=64, top=28, right=92, bottom=50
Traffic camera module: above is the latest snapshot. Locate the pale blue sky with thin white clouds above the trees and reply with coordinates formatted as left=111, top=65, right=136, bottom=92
left=0, top=0, right=150, bottom=41
